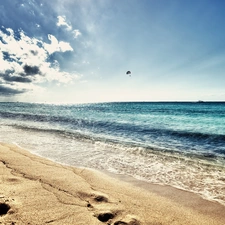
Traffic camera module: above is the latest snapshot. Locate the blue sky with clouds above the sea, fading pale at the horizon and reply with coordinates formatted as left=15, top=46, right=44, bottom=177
left=0, top=0, right=225, bottom=103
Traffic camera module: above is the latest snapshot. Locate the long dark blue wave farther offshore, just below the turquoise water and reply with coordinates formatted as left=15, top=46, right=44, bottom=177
left=0, top=108, right=225, bottom=146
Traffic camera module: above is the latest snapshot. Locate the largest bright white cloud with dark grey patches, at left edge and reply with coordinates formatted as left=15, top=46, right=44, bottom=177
left=0, top=27, right=79, bottom=95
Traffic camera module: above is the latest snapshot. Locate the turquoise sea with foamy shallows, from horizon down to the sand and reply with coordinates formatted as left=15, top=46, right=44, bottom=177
left=0, top=102, right=225, bottom=205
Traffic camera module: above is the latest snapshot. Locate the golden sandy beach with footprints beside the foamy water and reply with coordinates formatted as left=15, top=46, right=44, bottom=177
left=0, top=143, right=225, bottom=225
